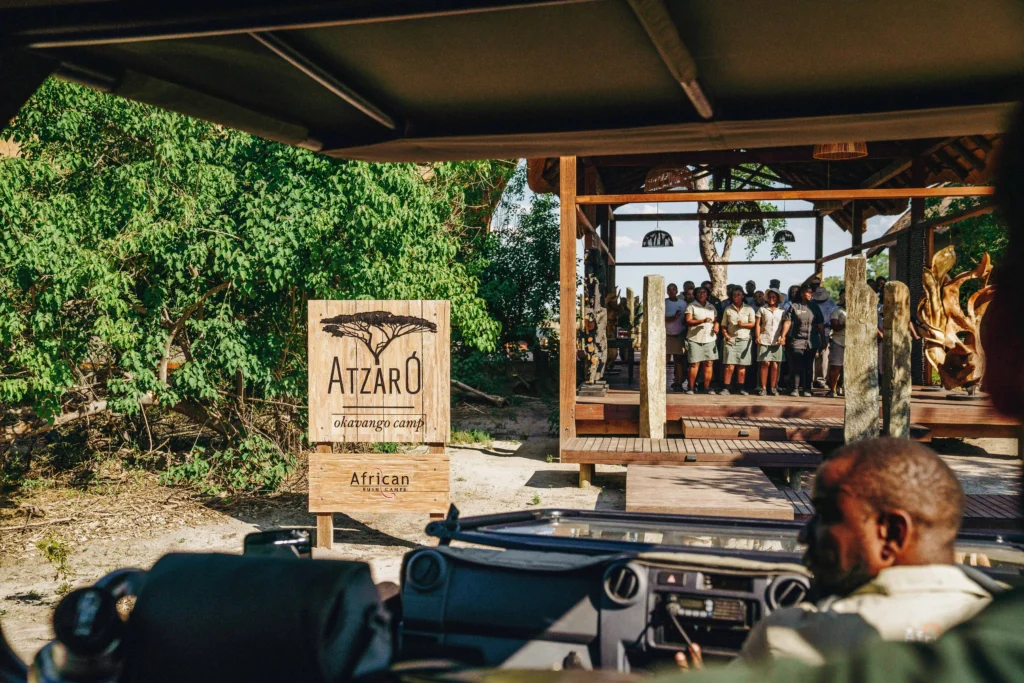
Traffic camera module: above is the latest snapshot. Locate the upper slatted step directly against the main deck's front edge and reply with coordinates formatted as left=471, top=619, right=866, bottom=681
left=681, top=417, right=932, bottom=443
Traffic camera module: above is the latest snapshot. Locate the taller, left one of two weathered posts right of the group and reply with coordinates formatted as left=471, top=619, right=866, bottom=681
left=843, top=256, right=879, bottom=443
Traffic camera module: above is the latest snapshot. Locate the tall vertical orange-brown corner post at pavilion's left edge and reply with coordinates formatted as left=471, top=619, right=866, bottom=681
left=558, top=157, right=580, bottom=444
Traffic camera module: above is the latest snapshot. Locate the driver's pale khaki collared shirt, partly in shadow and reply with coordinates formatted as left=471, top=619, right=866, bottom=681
left=739, top=564, right=992, bottom=665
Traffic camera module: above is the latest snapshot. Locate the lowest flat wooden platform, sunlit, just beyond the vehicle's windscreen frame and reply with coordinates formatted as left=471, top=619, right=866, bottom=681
left=626, top=465, right=794, bottom=519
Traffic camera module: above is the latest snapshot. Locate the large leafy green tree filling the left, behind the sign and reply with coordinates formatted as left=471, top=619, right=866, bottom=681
left=0, top=81, right=510, bottom=487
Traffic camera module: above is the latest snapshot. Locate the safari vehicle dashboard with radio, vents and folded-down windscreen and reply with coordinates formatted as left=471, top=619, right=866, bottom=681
left=397, top=510, right=1024, bottom=672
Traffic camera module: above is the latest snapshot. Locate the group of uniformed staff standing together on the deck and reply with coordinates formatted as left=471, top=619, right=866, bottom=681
left=665, top=278, right=846, bottom=396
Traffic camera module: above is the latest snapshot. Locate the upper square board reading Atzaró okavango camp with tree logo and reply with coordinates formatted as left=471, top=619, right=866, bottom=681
left=308, top=301, right=452, bottom=443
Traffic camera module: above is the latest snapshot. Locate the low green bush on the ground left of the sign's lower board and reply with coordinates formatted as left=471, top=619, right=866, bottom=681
left=160, top=435, right=295, bottom=496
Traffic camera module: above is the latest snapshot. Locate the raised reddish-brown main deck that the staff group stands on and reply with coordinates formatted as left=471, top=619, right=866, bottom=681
left=575, top=388, right=1021, bottom=438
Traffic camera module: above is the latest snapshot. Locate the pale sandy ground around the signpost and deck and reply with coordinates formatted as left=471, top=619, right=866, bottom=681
left=0, top=410, right=1021, bottom=658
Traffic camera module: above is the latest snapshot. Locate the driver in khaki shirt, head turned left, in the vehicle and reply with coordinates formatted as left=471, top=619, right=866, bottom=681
left=739, top=438, right=992, bottom=664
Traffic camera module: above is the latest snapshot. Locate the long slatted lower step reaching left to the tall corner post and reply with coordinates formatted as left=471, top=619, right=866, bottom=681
left=561, top=436, right=821, bottom=468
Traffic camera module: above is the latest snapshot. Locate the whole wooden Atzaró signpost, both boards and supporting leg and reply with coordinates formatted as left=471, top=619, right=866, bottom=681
left=308, top=301, right=452, bottom=548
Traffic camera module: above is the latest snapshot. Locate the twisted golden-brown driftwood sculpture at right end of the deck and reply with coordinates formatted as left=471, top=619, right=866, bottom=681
left=916, top=246, right=995, bottom=393
